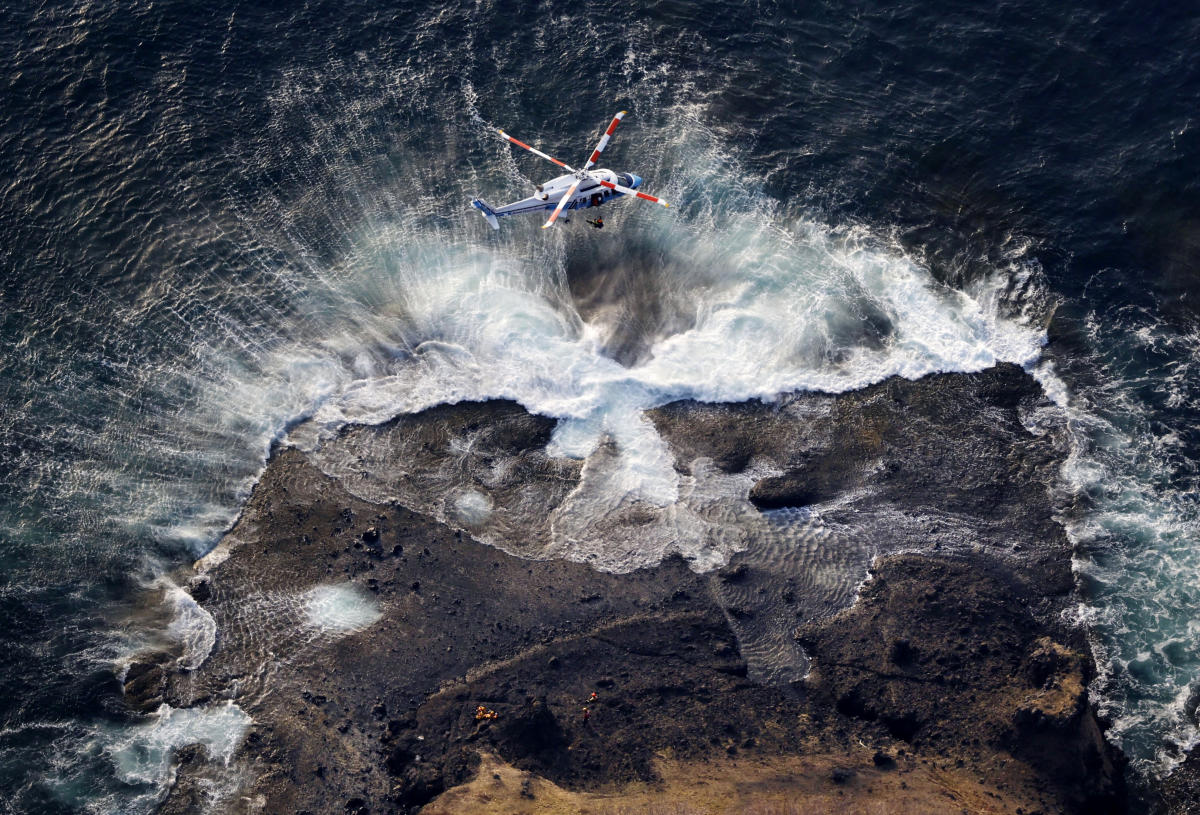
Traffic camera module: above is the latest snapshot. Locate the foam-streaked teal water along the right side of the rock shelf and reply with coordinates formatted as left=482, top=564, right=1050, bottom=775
left=1063, top=317, right=1200, bottom=779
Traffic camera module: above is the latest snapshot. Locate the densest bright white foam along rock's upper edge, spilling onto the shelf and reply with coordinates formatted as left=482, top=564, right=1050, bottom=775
left=276, top=204, right=1048, bottom=570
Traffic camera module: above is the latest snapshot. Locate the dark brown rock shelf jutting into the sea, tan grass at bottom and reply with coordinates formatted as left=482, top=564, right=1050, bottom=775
left=126, top=365, right=1152, bottom=813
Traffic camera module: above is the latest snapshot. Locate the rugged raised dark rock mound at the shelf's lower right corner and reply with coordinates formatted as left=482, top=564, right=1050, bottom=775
left=797, top=553, right=1124, bottom=813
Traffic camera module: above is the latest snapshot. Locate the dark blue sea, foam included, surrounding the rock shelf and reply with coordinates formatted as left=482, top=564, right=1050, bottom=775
left=0, top=0, right=1200, bottom=813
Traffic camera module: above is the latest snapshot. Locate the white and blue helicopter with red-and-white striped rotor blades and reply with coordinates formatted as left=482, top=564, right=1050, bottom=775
left=470, top=110, right=671, bottom=229
